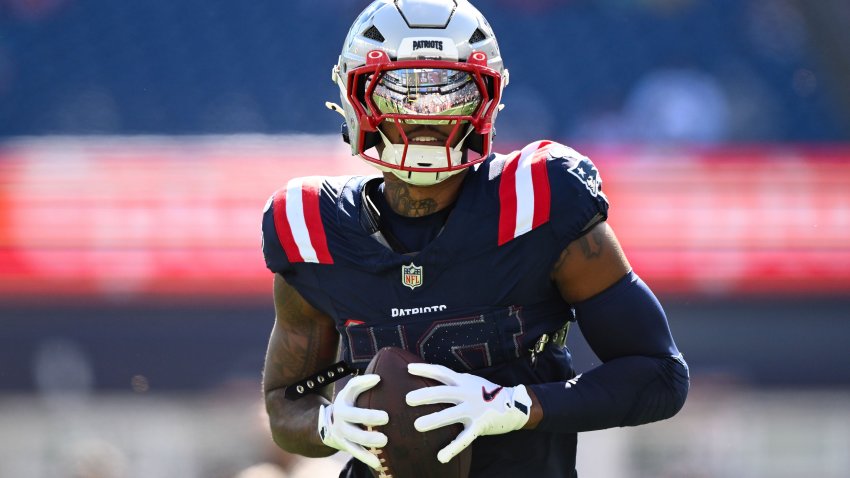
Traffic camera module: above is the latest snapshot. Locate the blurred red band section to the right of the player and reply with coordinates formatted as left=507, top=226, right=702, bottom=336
left=596, top=146, right=850, bottom=295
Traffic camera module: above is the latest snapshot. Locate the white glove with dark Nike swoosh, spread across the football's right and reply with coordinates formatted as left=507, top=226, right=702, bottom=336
left=405, top=363, right=531, bottom=463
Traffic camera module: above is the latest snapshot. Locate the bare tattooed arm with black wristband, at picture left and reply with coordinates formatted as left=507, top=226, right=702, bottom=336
left=263, top=274, right=339, bottom=457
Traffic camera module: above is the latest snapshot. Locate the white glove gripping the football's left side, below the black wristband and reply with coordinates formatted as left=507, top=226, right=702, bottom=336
left=319, top=374, right=389, bottom=470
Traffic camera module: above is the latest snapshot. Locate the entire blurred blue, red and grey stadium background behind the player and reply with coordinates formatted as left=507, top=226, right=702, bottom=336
left=0, top=0, right=850, bottom=478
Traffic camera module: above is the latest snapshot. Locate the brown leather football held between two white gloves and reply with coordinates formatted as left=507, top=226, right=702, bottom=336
left=357, top=347, right=472, bottom=478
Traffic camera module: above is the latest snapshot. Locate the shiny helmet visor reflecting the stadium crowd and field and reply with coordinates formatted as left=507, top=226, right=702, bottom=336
left=372, top=68, right=481, bottom=123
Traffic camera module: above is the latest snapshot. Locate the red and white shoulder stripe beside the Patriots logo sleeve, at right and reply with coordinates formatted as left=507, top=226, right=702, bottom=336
left=499, top=141, right=551, bottom=246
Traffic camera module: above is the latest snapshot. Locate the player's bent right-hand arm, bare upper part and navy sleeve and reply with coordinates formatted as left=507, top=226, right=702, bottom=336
left=527, top=222, right=688, bottom=432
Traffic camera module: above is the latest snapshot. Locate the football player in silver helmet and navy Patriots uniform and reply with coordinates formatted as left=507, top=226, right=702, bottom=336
left=263, top=0, right=689, bottom=478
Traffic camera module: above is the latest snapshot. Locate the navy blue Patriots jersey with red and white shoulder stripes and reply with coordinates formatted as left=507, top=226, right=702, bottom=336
left=263, top=141, right=608, bottom=477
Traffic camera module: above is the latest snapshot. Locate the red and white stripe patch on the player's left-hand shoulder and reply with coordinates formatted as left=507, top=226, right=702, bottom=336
left=273, top=176, right=333, bottom=264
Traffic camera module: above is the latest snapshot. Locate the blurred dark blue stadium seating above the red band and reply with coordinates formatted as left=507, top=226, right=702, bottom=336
left=0, top=0, right=848, bottom=142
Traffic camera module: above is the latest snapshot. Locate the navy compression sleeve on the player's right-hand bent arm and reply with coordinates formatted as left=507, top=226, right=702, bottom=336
left=531, top=272, right=689, bottom=432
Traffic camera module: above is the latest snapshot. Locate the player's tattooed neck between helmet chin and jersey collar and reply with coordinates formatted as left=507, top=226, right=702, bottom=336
left=384, top=171, right=466, bottom=217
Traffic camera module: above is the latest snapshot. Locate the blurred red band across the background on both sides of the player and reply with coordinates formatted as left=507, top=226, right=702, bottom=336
left=0, top=137, right=850, bottom=300
